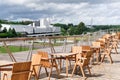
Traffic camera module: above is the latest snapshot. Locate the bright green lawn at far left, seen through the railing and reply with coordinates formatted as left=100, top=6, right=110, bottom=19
left=0, top=46, right=29, bottom=53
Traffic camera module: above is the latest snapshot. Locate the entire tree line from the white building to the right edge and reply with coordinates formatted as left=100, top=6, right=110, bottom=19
left=52, top=22, right=120, bottom=35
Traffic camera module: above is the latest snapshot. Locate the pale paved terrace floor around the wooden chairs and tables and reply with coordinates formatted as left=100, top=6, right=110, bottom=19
left=0, top=45, right=120, bottom=80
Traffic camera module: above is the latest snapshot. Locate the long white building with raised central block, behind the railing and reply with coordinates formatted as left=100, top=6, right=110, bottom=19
left=1, top=18, right=61, bottom=34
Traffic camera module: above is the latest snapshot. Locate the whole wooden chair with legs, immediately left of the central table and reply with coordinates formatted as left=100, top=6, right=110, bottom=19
left=38, top=51, right=59, bottom=80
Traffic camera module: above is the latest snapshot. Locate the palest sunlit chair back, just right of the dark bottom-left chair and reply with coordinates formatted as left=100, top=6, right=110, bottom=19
left=31, top=53, right=41, bottom=75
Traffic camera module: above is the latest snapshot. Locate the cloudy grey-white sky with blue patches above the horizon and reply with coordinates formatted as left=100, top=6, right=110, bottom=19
left=0, top=0, right=120, bottom=25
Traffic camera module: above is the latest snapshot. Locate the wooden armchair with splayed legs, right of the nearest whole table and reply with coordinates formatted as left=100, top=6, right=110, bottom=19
left=72, top=51, right=92, bottom=77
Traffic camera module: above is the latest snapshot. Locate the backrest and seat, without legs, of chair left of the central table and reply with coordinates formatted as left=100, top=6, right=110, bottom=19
left=38, top=51, right=51, bottom=67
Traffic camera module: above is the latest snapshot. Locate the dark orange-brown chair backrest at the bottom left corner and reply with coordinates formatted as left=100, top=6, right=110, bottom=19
left=11, top=62, right=31, bottom=80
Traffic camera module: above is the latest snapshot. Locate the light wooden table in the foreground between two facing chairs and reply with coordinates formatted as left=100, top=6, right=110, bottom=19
left=51, top=53, right=77, bottom=77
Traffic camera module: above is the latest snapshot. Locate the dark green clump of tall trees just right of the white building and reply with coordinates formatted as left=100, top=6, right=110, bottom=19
left=53, top=22, right=88, bottom=35
